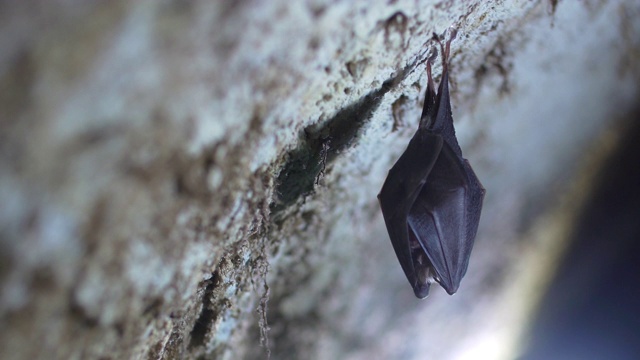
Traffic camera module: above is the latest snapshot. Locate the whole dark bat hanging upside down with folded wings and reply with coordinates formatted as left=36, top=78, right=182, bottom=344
left=378, top=30, right=485, bottom=299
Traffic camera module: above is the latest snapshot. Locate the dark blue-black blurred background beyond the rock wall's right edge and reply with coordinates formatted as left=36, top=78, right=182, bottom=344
left=523, top=112, right=640, bottom=360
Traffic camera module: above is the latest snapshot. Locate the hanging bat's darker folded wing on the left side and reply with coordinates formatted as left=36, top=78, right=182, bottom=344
left=378, top=131, right=443, bottom=298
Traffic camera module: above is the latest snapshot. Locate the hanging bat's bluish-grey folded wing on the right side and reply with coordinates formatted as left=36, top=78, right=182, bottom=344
left=408, top=142, right=484, bottom=294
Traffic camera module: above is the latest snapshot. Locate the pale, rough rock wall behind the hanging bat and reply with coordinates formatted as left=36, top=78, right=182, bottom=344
left=0, top=0, right=640, bottom=359
